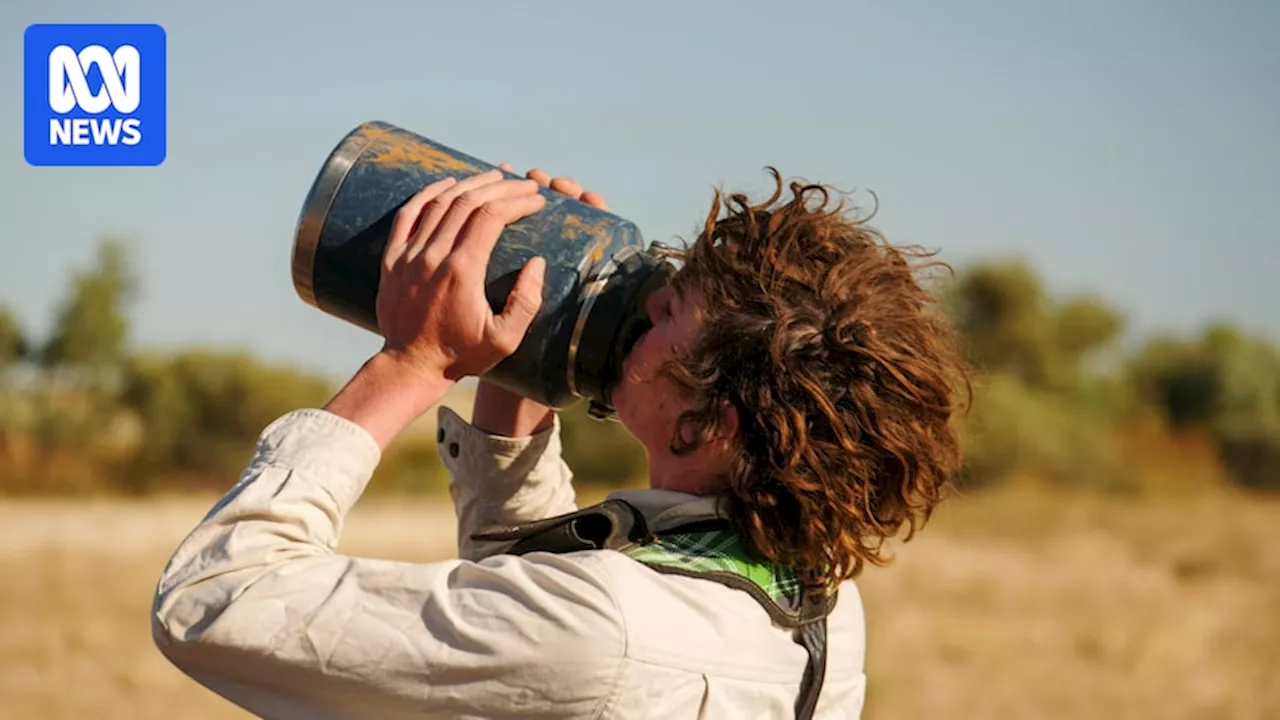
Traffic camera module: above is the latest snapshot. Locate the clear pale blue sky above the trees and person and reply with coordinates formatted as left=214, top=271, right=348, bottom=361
left=0, top=0, right=1280, bottom=374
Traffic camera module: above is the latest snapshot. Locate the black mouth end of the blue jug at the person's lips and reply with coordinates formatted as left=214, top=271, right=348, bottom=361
left=566, top=247, right=673, bottom=419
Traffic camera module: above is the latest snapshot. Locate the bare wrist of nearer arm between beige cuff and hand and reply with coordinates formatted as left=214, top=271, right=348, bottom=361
left=324, top=352, right=453, bottom=450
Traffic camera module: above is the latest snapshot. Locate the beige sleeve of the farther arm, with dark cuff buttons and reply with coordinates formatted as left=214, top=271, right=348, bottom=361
left=438, top=406, right=577, bottom=560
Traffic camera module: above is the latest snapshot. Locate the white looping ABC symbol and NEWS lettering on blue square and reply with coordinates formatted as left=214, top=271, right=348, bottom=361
left=49, top=45, right=142, bottom=145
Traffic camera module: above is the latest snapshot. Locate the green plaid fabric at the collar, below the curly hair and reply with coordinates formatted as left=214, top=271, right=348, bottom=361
left=626, top=529, right=800, bottom=607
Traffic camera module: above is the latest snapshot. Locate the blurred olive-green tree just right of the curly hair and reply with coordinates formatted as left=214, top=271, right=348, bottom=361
left=943, top=261, right=1129, bottom=488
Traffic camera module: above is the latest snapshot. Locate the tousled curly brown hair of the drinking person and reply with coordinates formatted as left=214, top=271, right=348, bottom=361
left=664, top=168, right=969, bottom=587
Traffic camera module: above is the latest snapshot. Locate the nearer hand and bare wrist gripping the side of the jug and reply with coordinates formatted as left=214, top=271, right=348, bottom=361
left=325, top=170, right=547, bottom=448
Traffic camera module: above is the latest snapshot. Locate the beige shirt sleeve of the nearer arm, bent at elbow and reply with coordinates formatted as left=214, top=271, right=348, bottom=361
left=152, top=410, right=625, bottom=719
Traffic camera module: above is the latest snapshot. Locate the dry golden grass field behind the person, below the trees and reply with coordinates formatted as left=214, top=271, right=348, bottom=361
left=0, top=484, right=1280, bottom=720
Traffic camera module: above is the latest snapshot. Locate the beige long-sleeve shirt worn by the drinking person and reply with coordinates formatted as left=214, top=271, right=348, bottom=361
left=152, top=407, right=865, bottom=720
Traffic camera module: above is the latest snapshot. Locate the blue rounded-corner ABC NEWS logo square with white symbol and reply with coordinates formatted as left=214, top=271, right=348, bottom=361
left=23, top=24, right=166, bottom=167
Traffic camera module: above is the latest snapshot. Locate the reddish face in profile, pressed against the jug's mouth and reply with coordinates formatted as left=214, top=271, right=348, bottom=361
left=612, top=286, right=701, bottom=486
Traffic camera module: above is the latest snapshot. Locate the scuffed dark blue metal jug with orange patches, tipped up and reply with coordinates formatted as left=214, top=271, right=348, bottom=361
left=292, top=122, right=672, bottom=418
